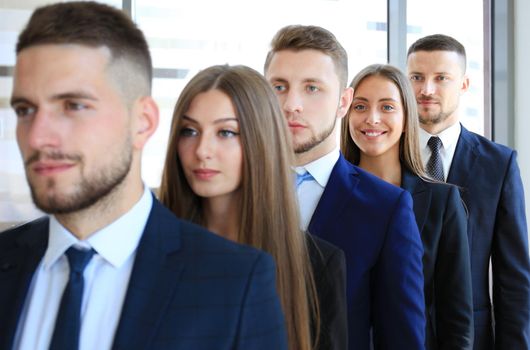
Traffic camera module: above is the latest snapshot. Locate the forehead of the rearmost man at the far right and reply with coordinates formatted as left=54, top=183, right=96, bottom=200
left=407, top=51, right=464, bottom=74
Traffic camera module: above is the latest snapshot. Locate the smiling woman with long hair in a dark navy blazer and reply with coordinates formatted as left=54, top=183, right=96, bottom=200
left=341, top=64, right=473, bottom=350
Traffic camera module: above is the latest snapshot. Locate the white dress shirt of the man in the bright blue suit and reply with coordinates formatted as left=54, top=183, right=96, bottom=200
left=294, top=148, right=340, bottom=231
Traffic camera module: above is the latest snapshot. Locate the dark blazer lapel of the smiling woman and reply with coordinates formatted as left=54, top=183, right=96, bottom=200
left=401, top=168, right=432, bottom=232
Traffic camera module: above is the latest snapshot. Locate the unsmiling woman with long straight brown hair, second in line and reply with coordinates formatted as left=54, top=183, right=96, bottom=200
left=160, top=66, right=346, bottom=350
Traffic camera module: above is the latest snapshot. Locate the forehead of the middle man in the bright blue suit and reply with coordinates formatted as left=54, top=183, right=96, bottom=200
left=265, top=49, right=339, bottom=84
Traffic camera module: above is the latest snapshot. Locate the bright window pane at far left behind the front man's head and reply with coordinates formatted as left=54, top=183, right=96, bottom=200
left=0, top=0, right=121, bottom=230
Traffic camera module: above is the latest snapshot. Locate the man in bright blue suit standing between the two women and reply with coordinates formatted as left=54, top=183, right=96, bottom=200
left=265, top=26, right=425, bottom=350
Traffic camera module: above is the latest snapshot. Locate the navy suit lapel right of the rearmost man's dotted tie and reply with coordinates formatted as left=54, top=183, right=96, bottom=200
left=447, top=126, right=478, bottom=188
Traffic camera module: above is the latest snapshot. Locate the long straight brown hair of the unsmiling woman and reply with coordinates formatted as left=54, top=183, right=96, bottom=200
left=160, top=65, right=318, bottom=350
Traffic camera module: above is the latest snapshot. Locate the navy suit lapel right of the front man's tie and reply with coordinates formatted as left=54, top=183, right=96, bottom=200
left=112, top=199, right=183, bottom=349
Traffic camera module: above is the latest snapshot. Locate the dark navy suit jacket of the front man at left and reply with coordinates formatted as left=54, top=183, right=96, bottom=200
left=0, top=199, right=287, bottom=350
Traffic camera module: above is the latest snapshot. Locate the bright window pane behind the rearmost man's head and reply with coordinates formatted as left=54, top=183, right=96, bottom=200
left=407, top=0, right=485, bottom=135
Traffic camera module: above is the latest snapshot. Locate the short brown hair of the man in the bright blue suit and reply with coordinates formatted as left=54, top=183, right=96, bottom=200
left=265, top=25, right=348, bottom=88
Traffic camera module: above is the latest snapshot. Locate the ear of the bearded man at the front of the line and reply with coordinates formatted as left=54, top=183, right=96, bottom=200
left=133, top=96, right=159, bottom=150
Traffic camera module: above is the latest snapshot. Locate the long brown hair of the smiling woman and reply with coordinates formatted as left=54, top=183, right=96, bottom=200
left=340, top=64, right=428, bottom=179
